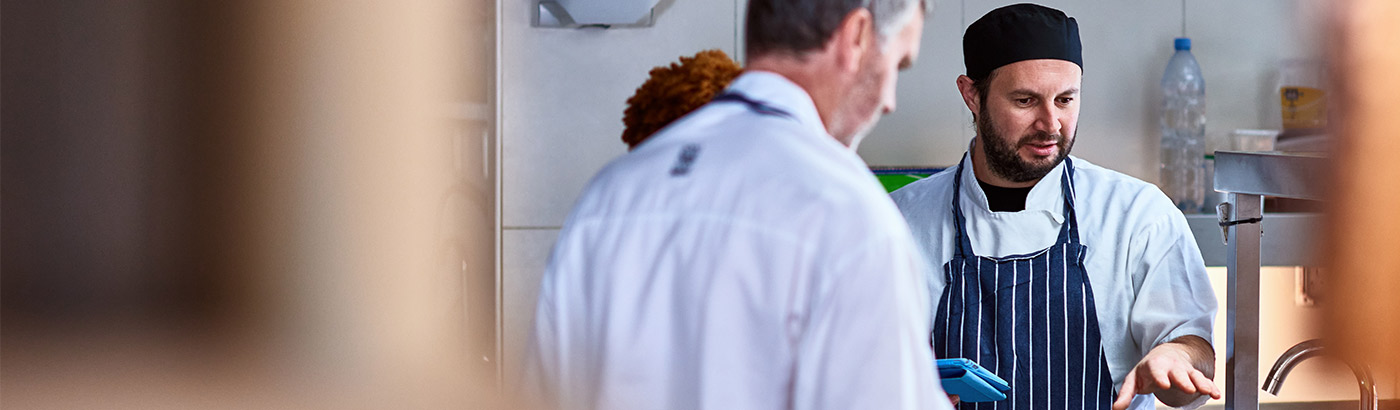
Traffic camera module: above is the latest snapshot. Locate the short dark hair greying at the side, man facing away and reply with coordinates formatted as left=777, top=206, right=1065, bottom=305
left=743, top=0, right=932, bottom=56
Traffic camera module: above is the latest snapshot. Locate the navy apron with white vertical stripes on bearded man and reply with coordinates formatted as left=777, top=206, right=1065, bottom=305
left=932, top=158, right=1114, bottom=410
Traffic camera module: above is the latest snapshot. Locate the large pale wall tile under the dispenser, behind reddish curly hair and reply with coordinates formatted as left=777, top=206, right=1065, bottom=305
left=501, top=0, right=736, bottom=228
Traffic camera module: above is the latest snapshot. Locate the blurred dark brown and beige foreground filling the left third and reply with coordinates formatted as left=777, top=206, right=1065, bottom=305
left=0, top=0, right=501, bottom=409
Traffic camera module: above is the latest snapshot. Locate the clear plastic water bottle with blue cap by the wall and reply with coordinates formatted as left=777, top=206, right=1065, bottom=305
left=1161, top=38, right=1205, bottom=214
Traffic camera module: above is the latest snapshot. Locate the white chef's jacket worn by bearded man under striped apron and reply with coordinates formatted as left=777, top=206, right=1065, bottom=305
left=892, top=154, right=1217, bottom=409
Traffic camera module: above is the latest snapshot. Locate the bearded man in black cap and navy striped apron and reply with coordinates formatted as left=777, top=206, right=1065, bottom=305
left=893, top=4, right=1219, bottom=409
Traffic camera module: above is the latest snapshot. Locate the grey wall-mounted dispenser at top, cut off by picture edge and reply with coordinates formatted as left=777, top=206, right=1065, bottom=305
left=531, top=0, right=658, bottom=28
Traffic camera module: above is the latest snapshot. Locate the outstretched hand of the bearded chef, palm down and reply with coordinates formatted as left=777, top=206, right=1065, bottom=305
left=1113, top=336, right=1221, bottom=410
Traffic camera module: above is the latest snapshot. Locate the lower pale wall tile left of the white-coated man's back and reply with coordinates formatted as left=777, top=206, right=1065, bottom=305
left=501, top=229, right=559, bottom=388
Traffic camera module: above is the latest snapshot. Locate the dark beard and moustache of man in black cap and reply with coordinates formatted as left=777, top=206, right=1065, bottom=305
left=974, top=105, right=1074, bottom=182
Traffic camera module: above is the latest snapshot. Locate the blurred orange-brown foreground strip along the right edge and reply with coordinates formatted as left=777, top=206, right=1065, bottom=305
left=1323, top=0, right=1400, bottom=374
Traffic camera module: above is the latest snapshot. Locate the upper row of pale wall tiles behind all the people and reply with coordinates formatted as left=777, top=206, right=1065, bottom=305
left=501, top=0, right=1324, bottom=222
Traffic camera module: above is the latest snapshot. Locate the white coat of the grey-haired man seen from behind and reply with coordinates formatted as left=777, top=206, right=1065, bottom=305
left=525, top=73, right=949, bottom=410
